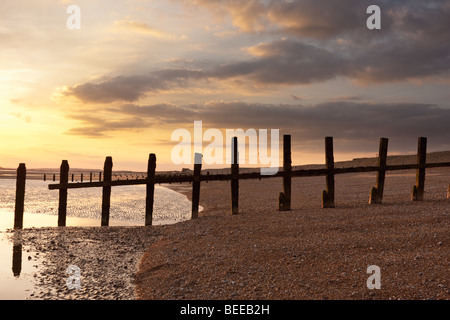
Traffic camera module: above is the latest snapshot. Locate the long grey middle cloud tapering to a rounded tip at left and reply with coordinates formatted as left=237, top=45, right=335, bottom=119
left=65, top=27, right=450, bottom=103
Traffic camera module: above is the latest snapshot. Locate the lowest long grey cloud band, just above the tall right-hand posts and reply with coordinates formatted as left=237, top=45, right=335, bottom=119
left=68, top=101, right=450, bottom=151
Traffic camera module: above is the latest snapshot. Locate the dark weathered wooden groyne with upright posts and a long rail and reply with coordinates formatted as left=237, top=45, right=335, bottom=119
left=8, top=135, right=450, bottom=228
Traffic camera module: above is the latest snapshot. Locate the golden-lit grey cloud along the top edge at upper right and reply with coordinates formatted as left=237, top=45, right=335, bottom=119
left=179, top=0, right=449, bottom=39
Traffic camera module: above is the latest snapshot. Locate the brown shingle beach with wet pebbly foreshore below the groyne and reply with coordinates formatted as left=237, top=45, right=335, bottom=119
left=4, top=169, right=450, bottom=300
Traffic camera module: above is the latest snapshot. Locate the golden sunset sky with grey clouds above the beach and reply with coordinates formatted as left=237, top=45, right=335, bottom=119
left=0, top=0, right=450, bottom=171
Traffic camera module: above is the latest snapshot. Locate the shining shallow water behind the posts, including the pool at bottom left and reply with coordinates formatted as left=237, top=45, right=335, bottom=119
left=0, top=179, right=203, bottom=300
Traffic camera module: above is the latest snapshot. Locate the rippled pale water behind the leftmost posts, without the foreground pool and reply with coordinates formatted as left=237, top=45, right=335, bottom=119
left=0, top=179, right=191, bottom=230
